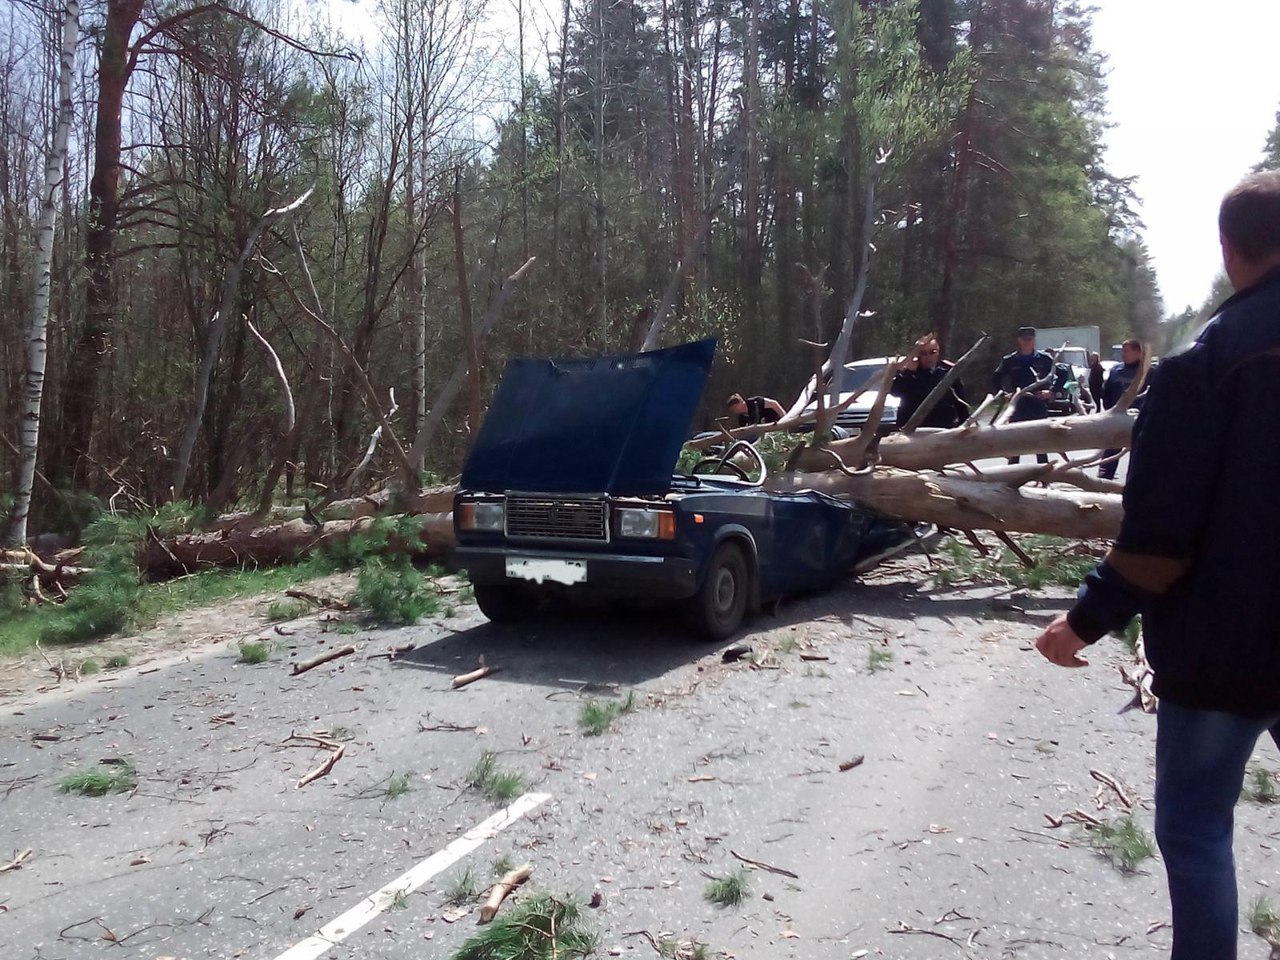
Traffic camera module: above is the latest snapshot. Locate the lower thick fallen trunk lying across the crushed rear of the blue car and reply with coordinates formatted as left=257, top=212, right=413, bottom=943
left=768, top=467, right=1124, bottom=540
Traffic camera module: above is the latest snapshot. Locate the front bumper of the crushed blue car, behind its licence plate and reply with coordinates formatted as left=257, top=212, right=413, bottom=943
left=449, top=544, right=698, bottom=599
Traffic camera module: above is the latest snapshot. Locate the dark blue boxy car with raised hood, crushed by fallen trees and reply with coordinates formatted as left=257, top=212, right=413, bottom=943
left=451, top=340, right=913, bottom=639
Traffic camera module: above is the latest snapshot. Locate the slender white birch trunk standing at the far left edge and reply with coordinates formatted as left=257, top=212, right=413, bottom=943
left=9, top=0, right=79, bottom=544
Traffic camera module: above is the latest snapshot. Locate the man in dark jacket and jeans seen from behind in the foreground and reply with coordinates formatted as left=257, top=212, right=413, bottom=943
left=1037, top=170, right=1280, bottom=960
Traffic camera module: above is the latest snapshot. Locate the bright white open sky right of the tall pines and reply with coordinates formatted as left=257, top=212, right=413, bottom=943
left=1093, top=0, right=1280, bottom=315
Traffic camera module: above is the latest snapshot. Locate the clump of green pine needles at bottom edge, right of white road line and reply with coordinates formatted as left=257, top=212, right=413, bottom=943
left=449, top=893, right=596, bottom=960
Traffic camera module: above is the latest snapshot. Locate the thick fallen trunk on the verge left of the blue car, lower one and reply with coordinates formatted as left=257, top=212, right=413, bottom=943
left=138, top=512, right=454, bottom=580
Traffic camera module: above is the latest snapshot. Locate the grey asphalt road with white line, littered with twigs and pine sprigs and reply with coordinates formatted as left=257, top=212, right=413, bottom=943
left=0, top=558, right=1280, bottom=960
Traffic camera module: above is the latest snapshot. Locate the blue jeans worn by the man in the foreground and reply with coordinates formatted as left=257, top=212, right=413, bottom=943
left=1156, top=700, right=1280, bottom=960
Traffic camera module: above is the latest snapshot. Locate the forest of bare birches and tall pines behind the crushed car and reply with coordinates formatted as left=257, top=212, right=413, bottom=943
left=0, top=0, right=1280, bottom=541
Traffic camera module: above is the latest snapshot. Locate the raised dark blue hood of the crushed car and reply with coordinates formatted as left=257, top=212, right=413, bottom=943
left=462, top=339, right=716, bottom=494
